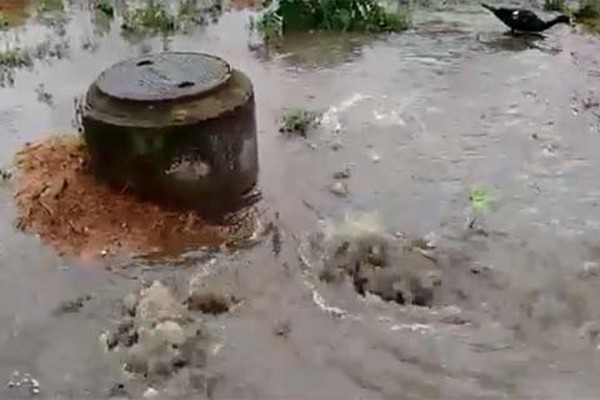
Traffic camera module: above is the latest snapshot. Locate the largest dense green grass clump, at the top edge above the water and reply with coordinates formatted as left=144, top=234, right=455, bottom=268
left=251, top=0, right=410, bottom=38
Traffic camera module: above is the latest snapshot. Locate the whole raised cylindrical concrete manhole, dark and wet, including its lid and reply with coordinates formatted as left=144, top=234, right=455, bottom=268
left=81, top=52, right=258, bottom=217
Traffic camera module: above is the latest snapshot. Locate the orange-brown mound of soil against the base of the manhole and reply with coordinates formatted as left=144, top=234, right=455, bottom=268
left=15, top=135, right=255, bottom=260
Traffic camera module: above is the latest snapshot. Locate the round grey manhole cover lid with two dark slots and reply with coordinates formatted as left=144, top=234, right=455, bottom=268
left=96, top=53, right=231, bottom=101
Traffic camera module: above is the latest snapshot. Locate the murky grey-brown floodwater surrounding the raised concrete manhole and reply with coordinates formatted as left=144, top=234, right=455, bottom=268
left=0, top=2, right=600, bottom=399
